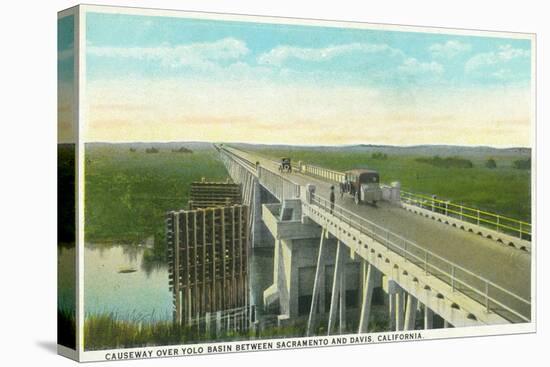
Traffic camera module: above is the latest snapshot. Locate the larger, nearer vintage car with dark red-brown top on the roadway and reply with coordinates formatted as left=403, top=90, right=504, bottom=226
left=340, top=169, right=382, bottom=205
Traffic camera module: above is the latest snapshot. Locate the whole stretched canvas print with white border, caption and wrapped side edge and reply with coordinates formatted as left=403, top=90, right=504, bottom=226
left=57, top=5, right=536, bottom=361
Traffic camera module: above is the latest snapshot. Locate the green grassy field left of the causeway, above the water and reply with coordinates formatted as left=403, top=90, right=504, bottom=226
left=85, top=144, right=227, bottom=243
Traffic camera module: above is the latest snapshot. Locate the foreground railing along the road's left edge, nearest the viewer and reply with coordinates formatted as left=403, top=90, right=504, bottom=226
left=305, top=195, right=531, bottom=322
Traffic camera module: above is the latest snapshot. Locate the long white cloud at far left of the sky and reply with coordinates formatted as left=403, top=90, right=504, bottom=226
left=87, top=38, right=249, bottom=68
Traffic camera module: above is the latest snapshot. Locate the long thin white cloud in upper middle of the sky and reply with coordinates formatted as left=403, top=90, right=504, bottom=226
left=258, top=42, right=401, bottom=66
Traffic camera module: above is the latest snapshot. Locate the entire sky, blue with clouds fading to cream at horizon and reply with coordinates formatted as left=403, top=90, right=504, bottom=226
left=86, top=13, right=531, bottom=145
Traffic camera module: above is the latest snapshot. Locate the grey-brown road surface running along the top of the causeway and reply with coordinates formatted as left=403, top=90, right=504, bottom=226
left=225, top=147, right=531, bottom=324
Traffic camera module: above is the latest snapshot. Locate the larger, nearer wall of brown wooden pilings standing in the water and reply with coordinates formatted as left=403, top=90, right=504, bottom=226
left=166, top=204, right=249, bottom=325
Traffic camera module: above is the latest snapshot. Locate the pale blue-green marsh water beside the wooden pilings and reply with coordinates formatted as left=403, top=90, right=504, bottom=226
left=59, top=244, right=273, bottom=321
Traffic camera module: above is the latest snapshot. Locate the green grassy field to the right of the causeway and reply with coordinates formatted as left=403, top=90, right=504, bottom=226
left=248, top=147, right=531, bottom=222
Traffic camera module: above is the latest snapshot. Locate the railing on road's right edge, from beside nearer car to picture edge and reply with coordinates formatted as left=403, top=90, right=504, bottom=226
left=401, top=190, right=531, bottom=241
